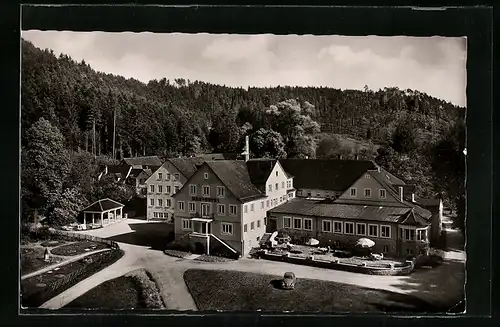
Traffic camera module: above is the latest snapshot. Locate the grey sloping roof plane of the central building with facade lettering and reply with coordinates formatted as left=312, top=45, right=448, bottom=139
left=205, top=160, right=266, bottom=202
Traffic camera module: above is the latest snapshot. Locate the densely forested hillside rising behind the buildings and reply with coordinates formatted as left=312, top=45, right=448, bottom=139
left=21, top=40, right=465, bottom=229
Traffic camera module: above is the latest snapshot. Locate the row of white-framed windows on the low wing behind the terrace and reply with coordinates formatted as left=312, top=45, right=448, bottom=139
left=283, top=217, right=391, bottom=238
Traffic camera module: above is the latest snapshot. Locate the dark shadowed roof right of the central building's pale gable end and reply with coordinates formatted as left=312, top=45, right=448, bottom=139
left=279, top=159, right=377, bottom=192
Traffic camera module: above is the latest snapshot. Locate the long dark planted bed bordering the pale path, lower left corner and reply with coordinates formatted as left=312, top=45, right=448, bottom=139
left=21, top=250, right=124, bottom=308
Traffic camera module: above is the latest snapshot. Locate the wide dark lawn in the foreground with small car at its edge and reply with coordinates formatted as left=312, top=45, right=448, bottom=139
left=184, top=269, right=438, bottom=313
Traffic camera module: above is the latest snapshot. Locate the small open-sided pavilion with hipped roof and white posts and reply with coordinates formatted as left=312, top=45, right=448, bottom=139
left=82, top=198, right=124, bottom=227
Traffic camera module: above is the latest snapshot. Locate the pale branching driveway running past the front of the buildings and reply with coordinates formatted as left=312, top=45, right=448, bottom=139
left=41, top=219, right=465, bottom=310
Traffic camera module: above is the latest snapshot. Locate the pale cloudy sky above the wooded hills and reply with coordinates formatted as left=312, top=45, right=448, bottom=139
left=22, top=30, right=467, bottom=107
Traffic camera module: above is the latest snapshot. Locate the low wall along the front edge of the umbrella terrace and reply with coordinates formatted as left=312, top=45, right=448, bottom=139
left=257, top=253, right=414, bottom=276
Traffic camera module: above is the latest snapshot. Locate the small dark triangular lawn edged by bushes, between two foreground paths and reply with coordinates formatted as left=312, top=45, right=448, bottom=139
left=65, top=269, right=164, bottom=309
